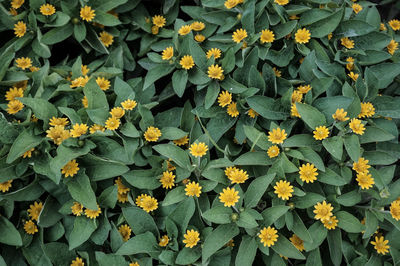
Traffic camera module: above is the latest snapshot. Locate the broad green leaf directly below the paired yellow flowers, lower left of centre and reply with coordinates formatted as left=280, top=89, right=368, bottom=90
left=122, top=206, right=159, bottom=236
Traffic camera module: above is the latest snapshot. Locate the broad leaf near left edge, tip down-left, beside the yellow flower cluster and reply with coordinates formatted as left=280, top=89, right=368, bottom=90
left=6, top=129, right=43, bottom=164
